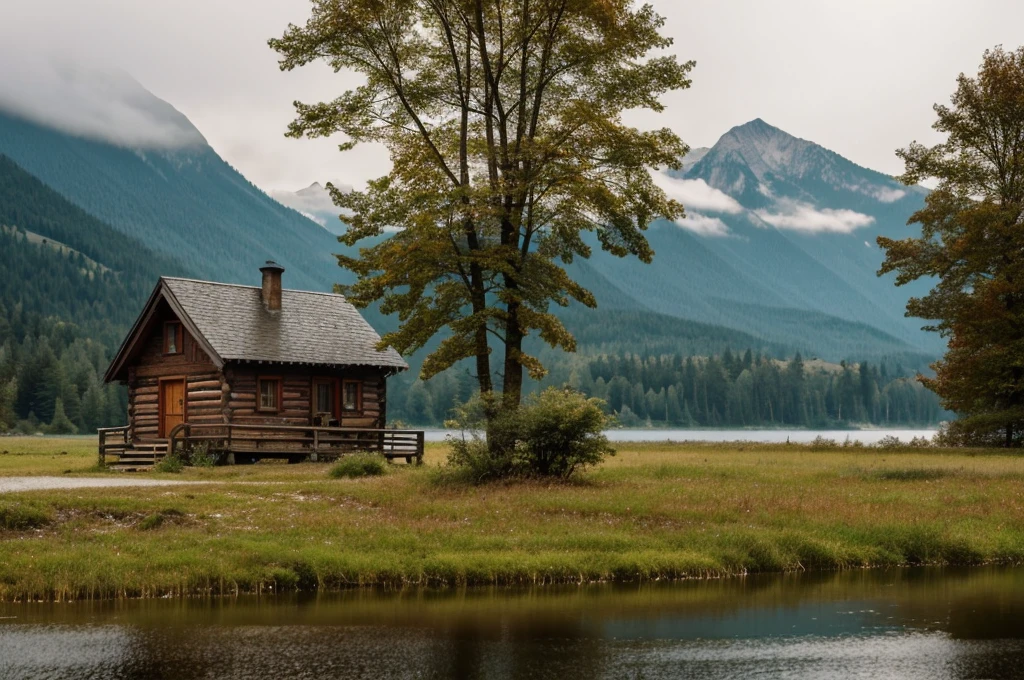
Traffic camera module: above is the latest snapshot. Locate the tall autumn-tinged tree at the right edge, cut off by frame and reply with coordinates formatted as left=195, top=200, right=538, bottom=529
left=879, top=47, right=1024, bottom=447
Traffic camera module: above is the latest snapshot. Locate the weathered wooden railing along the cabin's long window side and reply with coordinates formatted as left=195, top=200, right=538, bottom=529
left=167, top=423, right=424, bottom=465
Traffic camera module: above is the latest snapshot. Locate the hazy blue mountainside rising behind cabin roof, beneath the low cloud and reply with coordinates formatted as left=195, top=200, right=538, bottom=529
left=0, top=97, right=343, bottom=290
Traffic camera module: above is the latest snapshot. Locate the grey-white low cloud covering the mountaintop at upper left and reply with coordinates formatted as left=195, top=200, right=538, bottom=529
left=0, top=51, right=206, bottom=150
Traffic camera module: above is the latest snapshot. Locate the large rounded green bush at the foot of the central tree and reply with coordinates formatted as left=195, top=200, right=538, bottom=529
left=449, top=387, right=614, bottom=481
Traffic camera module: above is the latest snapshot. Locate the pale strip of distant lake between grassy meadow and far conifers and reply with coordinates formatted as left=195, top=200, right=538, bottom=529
left=426, top=429, right=936, bottom=444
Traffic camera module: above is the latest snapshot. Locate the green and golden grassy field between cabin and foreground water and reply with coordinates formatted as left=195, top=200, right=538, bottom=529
left=0, top=437, right=1024, bottom=600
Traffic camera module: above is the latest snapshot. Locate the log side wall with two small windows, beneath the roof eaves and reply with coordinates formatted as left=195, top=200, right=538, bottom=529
left=224, top=365, right=387, bottom=427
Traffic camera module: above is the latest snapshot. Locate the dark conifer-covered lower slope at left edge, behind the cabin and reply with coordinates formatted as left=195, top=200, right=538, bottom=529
left=0, top=155, right=189, bottom=431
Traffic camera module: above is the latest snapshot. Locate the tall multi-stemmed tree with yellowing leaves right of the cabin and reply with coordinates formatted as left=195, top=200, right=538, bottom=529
left=270, top=0, right=693, bottom=408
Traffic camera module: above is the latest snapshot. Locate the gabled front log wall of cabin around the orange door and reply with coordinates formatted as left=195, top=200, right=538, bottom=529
left=128, top=308, right=219, bottom=439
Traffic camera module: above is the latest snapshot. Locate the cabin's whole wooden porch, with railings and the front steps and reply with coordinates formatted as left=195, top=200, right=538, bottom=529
left=98, top=423, right=424, bottom=470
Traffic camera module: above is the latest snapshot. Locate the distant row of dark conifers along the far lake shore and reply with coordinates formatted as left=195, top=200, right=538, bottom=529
left=388, top=349, right=951, bottom=428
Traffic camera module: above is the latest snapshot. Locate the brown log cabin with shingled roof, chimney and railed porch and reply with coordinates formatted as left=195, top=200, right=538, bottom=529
left=99, top=261, right=423, bottom=468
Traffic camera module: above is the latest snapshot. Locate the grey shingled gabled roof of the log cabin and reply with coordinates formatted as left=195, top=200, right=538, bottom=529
left=105, top=277, right=409, bottom=381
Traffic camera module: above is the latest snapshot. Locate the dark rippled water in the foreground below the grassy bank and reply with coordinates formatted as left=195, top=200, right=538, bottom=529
left=0, top=567, right=1024, bottom=680
